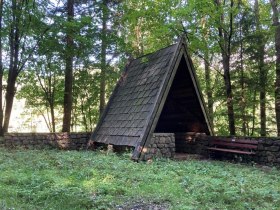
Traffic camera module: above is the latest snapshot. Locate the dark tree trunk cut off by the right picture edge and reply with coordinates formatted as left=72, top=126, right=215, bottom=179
left=270, top=0, right=280, bottom=136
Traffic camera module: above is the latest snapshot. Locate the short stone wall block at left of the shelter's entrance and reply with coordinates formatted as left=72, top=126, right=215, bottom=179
left=142, top=133, right=175, bottom=160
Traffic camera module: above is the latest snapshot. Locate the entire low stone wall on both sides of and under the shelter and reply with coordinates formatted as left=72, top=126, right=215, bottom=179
left=0, top=133, right=280, bottom=166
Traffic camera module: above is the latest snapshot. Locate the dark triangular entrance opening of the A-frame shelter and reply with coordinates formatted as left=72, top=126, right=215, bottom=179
left=154, top=56, right=210, bottom=152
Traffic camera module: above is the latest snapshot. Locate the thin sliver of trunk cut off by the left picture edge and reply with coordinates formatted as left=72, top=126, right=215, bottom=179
left=0, top=0, right=4, bottom=136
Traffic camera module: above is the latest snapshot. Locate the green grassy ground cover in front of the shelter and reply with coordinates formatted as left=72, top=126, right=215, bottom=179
left=0, top=149, right=280, bottom=210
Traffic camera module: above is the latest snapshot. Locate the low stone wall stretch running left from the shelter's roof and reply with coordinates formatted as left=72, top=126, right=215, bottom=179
left=0, top=133, right=91, bottom=150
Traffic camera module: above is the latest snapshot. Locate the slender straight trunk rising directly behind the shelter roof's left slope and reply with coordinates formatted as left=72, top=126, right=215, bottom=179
left=99, top=0, right=108, bottom=116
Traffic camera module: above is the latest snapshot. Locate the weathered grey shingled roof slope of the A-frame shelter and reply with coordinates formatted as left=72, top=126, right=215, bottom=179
left=91, top=41, right=212, bottom=159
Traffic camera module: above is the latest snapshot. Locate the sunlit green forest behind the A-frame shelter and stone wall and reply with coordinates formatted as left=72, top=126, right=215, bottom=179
left=0, top=0, right=280, bottom=136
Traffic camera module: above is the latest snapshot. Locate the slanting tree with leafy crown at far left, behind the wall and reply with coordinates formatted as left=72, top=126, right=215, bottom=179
left=0, top=0, right=48, bottom=135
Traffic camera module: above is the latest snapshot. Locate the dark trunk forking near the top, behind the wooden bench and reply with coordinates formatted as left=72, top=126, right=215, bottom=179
left=215, top=0, right=235, bottom=135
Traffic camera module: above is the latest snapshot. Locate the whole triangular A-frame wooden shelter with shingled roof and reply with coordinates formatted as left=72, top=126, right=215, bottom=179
left=91, top=40, right=212, bottom=160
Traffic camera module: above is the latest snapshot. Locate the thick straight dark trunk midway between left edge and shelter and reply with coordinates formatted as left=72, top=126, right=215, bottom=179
left=62, top=0, right=74, bottom=132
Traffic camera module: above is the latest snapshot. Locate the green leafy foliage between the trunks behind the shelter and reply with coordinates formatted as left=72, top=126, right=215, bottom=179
left=1, top=0, right=275, bottom=136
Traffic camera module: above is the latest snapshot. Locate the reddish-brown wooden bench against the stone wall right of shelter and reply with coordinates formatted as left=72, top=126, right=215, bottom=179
left=207, top=138, right=258, bottom=155
